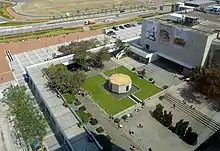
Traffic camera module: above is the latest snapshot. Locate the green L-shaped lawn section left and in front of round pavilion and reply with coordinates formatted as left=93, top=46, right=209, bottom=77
left=83, top=75, right=135, bottom=115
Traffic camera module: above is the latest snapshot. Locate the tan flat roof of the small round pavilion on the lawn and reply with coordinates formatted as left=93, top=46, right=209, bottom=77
left=109, top=73, right=131, bottom=85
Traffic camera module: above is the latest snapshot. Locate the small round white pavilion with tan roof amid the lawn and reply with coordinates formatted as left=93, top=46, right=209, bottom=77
left=109, top=73, right=132, bottom=94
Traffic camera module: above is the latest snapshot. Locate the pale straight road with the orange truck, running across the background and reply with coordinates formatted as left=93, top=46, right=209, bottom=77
left=0, top=10, right=162, bottom=36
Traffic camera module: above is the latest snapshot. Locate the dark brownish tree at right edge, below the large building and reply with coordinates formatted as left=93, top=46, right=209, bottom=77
left=190, top=65, right=220, bottom=97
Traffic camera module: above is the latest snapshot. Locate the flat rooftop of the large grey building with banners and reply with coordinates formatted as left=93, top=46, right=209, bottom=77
left=151, top=11, right=220, bottom=35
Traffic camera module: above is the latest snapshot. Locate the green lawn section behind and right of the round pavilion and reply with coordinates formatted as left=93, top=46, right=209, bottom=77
left=105, top=66, right=160, bottom=100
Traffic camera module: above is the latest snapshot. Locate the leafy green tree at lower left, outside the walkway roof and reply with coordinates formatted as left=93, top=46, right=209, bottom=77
left=4, top=86, right=47, bottom=146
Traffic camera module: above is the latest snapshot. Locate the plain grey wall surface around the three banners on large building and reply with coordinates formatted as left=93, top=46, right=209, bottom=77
left=141, top=20, right=217, bottom=68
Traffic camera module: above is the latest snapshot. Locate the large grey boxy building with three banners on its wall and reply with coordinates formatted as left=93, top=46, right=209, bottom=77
left=140, top=12, right=218, bottom=69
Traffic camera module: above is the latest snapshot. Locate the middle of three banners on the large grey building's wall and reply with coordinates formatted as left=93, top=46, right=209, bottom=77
left=159, top=24, right=172, bottom=44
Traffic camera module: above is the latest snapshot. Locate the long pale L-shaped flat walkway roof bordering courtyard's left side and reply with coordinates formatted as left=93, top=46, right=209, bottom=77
left=26, top=55, right=99, bottom=151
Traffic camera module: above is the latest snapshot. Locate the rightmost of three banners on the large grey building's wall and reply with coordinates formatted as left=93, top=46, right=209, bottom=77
left=173, top=28, right=188, bottom=47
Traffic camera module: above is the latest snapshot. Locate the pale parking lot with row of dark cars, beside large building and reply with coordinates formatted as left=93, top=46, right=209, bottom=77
left=105, top=23, right=142, bottom=40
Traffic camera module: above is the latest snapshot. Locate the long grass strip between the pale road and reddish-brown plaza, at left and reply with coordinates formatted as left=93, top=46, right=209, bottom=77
left=0, top=28, right=82, bottom=42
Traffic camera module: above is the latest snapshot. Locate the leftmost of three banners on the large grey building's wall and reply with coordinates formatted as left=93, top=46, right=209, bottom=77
left=146, top=21, right=157, bottom=41
